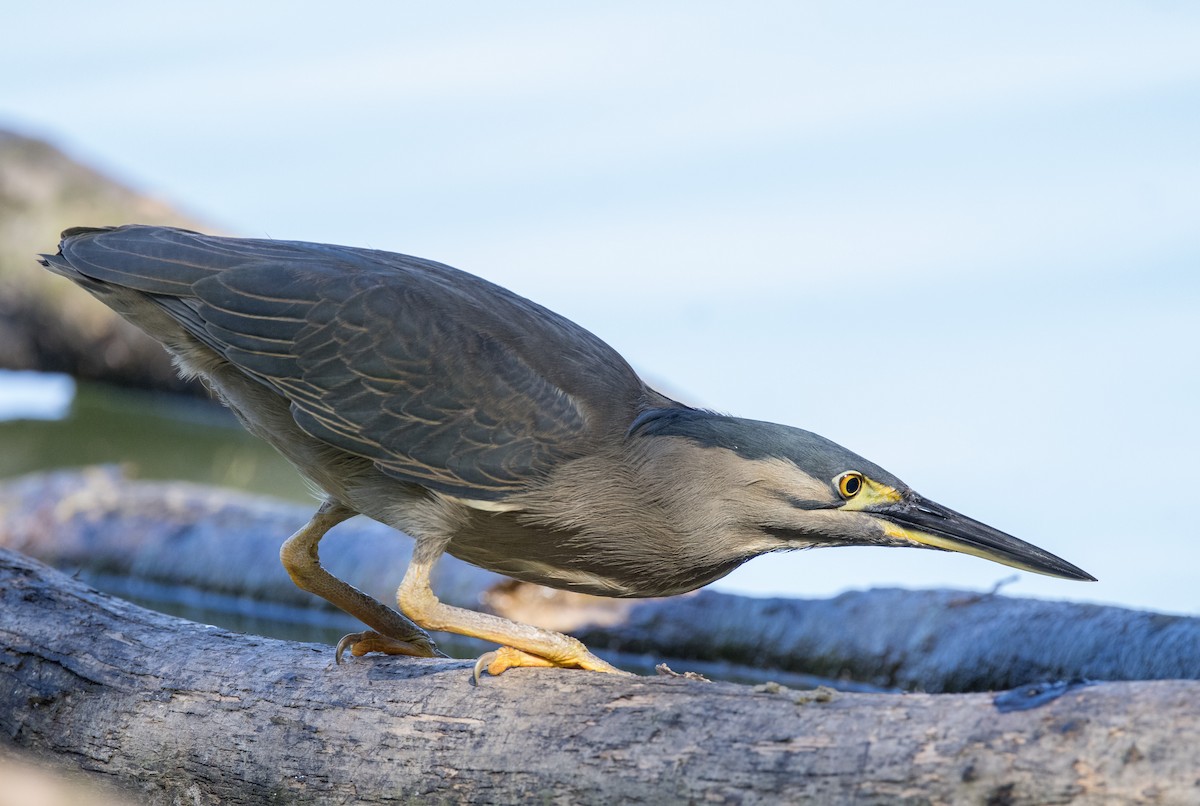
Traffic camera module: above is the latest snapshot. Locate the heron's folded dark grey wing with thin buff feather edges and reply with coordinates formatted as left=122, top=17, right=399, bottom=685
left=48, top=227, right=644, bottom=500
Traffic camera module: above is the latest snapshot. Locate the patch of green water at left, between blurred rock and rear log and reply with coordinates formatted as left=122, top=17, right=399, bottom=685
left=0, top=384, right=313, bottom=503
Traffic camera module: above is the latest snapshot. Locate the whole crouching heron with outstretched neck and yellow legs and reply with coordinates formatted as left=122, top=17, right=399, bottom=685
left=41, top=225, right=1094, bottom=682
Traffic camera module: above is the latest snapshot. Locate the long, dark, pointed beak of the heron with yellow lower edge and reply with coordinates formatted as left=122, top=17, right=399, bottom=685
left=871, top=494, right=1096, bottom=582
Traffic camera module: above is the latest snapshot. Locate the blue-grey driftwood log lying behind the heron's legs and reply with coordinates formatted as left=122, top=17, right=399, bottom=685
left=0, top=469, right=1200, bottom=691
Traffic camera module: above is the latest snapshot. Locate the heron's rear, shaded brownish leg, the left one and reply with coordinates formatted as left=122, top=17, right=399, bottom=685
left=280, top=501, right=445, bottom=663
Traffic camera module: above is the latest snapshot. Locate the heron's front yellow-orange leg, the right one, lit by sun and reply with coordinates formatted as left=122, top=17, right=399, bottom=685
left=396, top=537, right=628, bottom=682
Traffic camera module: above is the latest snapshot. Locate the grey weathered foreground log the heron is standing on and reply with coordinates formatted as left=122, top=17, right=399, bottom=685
left=0, top=551, right=1200, bottom=804
